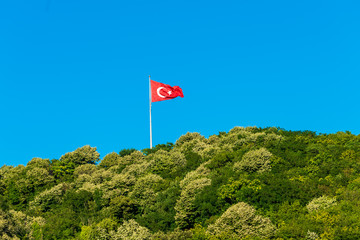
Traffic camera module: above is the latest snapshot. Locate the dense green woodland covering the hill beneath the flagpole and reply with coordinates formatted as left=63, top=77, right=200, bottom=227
left=0, top=127, right=360, bottom=240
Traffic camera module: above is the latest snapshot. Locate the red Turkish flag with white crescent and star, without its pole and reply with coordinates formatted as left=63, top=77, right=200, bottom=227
left=151, top=80, right=184, bottom=102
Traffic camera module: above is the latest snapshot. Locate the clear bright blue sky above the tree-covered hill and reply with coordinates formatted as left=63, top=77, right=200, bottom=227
left=0, top=0, right=360, bottom=166
